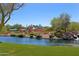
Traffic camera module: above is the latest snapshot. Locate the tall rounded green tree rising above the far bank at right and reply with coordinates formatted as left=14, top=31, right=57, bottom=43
left=51, top=13, right=70, bottom=37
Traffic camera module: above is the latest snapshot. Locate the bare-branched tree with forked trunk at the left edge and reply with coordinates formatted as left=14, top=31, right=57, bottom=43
left=0, top=3, right=23, bottom=31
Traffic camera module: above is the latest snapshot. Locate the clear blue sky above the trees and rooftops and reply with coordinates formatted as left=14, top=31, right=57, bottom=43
left=7, top=3, right=79, bottom=26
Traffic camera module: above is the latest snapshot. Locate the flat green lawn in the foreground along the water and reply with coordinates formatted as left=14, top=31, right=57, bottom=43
left=0, top=43, right=79, bottom=56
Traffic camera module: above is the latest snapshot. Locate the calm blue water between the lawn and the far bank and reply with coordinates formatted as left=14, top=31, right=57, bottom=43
left=0, top=37, right=78, bottom=46
